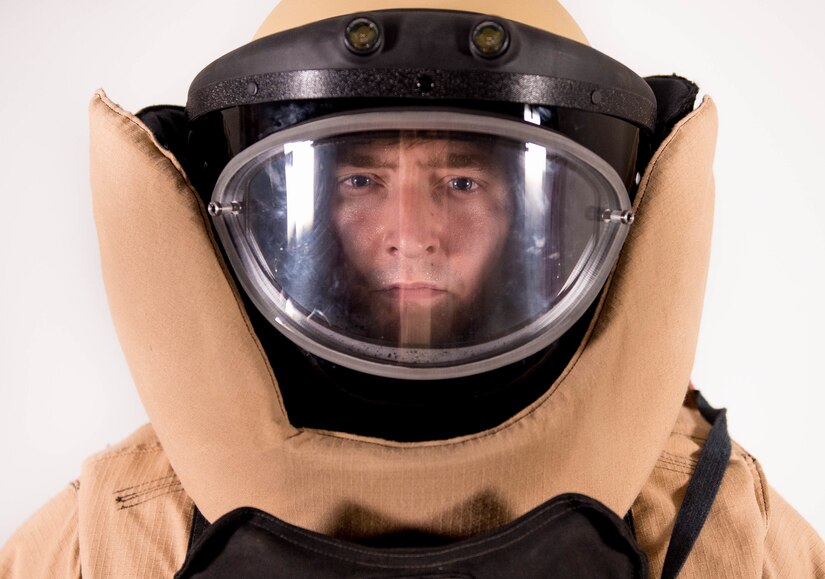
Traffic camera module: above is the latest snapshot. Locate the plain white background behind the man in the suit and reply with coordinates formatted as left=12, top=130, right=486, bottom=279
left=0, top=0, right=825, bottom=544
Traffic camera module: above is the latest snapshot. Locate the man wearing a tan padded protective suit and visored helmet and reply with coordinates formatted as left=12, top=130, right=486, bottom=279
left=1, top=3, right=822, bottom=576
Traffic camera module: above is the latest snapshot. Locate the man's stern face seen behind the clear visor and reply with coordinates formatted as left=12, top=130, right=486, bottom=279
left=332, top=137, right=512, bottom=347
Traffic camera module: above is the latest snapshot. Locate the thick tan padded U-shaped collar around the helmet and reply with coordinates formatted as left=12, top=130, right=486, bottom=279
left=90, top=92, right=716, bottom=537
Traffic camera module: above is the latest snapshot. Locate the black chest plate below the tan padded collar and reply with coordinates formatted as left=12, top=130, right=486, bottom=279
left=176, top=494, right=647, bottom=579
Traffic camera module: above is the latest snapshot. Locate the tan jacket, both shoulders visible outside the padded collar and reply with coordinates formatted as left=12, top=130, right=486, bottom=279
left=0, top=407, right=825, bottom=579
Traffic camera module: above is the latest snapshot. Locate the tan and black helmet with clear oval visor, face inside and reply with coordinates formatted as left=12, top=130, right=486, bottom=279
left=186, top=0, right=656, bottom=384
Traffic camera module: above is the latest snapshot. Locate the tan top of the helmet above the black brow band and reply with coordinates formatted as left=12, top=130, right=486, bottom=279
left=255, top=0, right=588, bottom=44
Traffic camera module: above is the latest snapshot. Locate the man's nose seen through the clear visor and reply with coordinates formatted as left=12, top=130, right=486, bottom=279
left=386, top=176, right=446, bottom=258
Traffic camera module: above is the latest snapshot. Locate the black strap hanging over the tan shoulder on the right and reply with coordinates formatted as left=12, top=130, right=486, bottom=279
left=662, top=390, right=731, bottom=579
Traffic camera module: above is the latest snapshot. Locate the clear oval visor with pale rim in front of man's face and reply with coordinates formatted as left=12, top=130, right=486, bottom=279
left=210, top=111, right=630, bottom=379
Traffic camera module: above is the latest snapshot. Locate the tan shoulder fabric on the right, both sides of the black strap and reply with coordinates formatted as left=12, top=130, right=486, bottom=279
left=633, top=406, right=825, bottom=579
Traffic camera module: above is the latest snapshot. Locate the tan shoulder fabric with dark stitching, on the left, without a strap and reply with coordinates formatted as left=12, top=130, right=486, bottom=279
left=0, top=425, right=194, bottom=579
